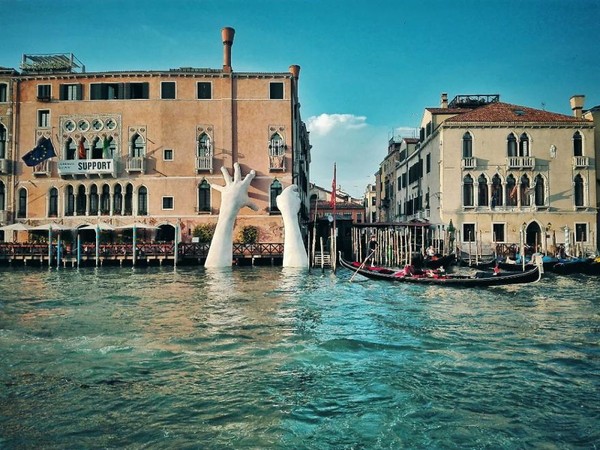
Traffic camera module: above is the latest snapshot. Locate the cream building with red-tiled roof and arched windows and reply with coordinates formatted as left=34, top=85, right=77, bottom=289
left=399, top=94, right=598, bottom=254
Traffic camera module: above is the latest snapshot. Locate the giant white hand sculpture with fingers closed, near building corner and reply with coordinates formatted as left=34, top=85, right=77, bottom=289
left=275, top=184, right=308, bottom=267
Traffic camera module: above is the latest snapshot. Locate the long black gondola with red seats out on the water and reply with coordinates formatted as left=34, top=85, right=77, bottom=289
left=339, top=254, right=543, bottom=287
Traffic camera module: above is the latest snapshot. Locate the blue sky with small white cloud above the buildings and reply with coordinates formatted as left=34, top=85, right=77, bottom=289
left=0, top=0, right=600, bottom=197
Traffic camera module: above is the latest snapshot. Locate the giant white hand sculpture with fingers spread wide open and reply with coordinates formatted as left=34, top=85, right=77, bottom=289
left=204, top=163, right=258, bottom=267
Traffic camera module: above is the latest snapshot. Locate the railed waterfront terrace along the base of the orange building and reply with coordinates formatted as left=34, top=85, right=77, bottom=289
left=0, top=242, right=283, bottom=267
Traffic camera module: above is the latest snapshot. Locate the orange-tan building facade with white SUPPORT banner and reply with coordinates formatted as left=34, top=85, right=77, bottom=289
left=0, top=28, right=310, bottom=246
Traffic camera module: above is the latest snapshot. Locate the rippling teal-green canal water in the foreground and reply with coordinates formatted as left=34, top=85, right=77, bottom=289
left=0, top=267, right=600, bottom=449
